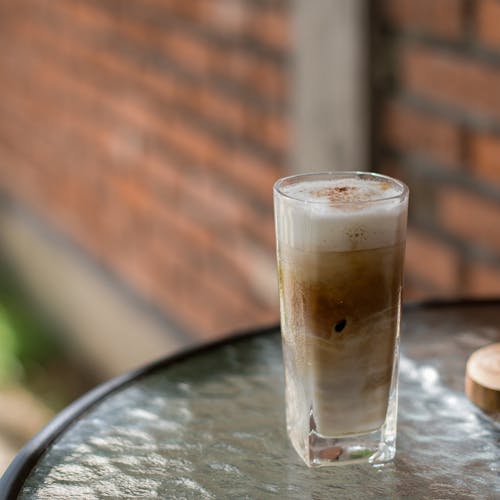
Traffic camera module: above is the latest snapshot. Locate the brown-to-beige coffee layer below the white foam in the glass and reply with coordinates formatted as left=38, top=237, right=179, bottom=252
left=280, top=244, right=404, bottom=436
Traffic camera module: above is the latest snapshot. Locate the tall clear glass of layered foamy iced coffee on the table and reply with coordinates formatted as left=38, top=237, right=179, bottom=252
left=274, top=172, right=408, bottom=467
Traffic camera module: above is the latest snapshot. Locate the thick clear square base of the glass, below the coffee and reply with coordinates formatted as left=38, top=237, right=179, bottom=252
left=293, top=430, right=396, bottom=467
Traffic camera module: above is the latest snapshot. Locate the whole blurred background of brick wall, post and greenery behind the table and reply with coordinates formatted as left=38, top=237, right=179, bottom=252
left=0, top=0, right=500, bottom=471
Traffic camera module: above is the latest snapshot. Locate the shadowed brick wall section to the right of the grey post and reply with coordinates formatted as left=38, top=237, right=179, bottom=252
left=374, top=0, right=500, bottom=297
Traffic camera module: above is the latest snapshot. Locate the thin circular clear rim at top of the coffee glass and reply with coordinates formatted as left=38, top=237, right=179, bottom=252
left=273, top=170, right=409, bottom=205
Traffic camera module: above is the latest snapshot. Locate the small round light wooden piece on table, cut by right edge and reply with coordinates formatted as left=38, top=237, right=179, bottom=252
left=465, top=342, right=500, bottom=413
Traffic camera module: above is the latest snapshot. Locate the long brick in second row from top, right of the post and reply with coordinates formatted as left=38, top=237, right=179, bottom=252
left=401, top=46, right=500, bottom=117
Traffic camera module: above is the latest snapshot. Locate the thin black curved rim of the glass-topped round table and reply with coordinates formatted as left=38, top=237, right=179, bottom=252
left=0, top=298, right=500, bottom=500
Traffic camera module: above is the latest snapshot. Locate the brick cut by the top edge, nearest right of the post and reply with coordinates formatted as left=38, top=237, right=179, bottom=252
left=383, top=0, right=464, bottom=39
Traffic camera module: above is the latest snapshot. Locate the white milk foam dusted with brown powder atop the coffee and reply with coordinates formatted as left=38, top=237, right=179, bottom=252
left=277, top=178, right=406, bottom=252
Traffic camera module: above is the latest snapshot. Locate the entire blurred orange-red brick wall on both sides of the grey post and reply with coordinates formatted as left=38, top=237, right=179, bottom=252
left=0, top=0, right=500, bottom=346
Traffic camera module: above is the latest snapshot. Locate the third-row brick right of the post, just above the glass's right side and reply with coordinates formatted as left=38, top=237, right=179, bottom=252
left=382, top=101, right=462, bottom=167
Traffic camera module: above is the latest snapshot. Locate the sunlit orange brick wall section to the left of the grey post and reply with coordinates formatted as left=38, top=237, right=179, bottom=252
left=0, top=0, right=289, bottom=336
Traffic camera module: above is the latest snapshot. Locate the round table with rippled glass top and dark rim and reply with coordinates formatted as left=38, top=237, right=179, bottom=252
left=0, top=300, right=500, bottom=500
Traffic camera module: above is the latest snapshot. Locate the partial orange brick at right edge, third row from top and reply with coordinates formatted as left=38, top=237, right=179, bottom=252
left=471, top=133, right=500, bottom=187
